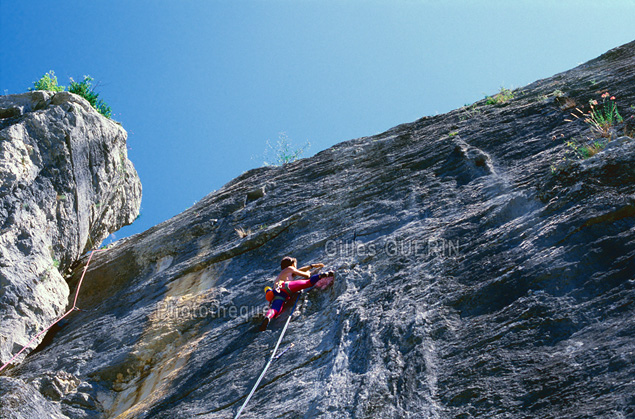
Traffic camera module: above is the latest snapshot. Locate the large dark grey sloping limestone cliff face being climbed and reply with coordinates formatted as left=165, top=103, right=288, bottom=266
left=0, top=43, right=635, bottom=419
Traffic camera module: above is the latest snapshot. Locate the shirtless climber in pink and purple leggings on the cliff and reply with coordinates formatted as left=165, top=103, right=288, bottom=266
left=260, top=256, right=335, bottom=332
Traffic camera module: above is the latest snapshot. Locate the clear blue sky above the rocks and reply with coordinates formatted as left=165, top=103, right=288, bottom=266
left=0, top=0, right=635, bottom=243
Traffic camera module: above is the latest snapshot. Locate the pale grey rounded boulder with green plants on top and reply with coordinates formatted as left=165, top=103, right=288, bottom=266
left=0, top=91, right=141, bottom=364
